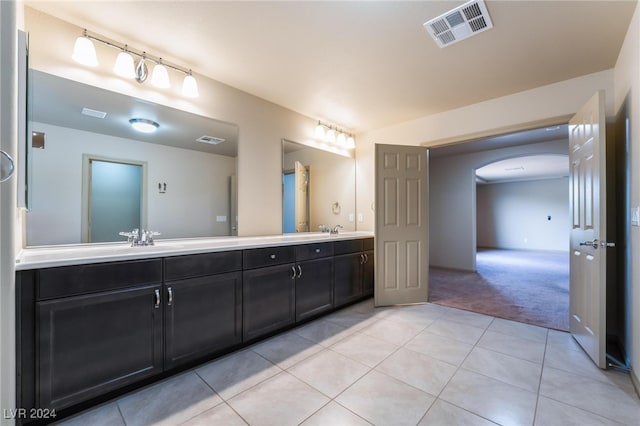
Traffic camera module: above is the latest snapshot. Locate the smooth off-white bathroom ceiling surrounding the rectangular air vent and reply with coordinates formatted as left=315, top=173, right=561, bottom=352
left=25, top=0, right=636, bottom=132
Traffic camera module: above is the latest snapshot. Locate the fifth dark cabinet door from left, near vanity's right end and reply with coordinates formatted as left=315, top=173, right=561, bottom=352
left=333, top=253, right=363, bottom=307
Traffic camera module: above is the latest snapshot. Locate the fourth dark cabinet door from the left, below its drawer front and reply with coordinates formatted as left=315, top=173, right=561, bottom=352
left=296, top=258, right=333, bottom=321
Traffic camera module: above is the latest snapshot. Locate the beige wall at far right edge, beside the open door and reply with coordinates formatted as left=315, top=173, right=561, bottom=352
left=614, top=0, right=640, bottom=389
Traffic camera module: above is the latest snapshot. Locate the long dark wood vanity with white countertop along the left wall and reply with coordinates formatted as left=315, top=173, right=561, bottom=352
left=16, top=232, right=374, bottom=423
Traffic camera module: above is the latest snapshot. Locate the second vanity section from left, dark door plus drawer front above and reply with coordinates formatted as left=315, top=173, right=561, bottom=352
left=163, top=251, right=242, bottom=369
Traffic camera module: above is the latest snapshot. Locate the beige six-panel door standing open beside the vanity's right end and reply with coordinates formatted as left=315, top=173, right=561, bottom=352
left=374, top=145, right=429, bottom=306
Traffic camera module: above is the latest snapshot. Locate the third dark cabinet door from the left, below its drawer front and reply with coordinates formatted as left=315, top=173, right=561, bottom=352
left=242, top=264, right=295, bottom=341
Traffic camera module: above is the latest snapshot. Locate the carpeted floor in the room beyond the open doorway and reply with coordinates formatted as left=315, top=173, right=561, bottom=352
left=429, top=249, right=569, bottom=330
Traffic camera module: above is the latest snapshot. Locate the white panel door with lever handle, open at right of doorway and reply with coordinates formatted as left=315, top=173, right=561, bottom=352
left=569, top=91, right=607, bottom=368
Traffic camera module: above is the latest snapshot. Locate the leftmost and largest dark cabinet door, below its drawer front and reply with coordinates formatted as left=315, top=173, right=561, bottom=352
left=36, top=285, right=163, bottom=409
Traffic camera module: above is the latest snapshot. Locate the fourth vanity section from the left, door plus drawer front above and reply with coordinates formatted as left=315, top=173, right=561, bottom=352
left=295, top=243, right=333, bottom=321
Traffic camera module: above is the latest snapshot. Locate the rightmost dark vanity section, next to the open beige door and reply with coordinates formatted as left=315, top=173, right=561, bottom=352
left=333, top=238, right=373, bottom=307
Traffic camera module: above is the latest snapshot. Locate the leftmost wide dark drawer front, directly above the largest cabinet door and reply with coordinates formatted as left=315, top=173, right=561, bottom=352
left=36, top=259, right=162, bottom=300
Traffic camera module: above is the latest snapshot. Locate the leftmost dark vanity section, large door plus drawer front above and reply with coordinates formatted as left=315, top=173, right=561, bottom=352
left=19, top=260, right=163, bottom=409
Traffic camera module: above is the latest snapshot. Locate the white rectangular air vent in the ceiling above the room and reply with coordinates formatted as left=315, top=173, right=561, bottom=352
left=423, top=0, right=493, bottom=47
